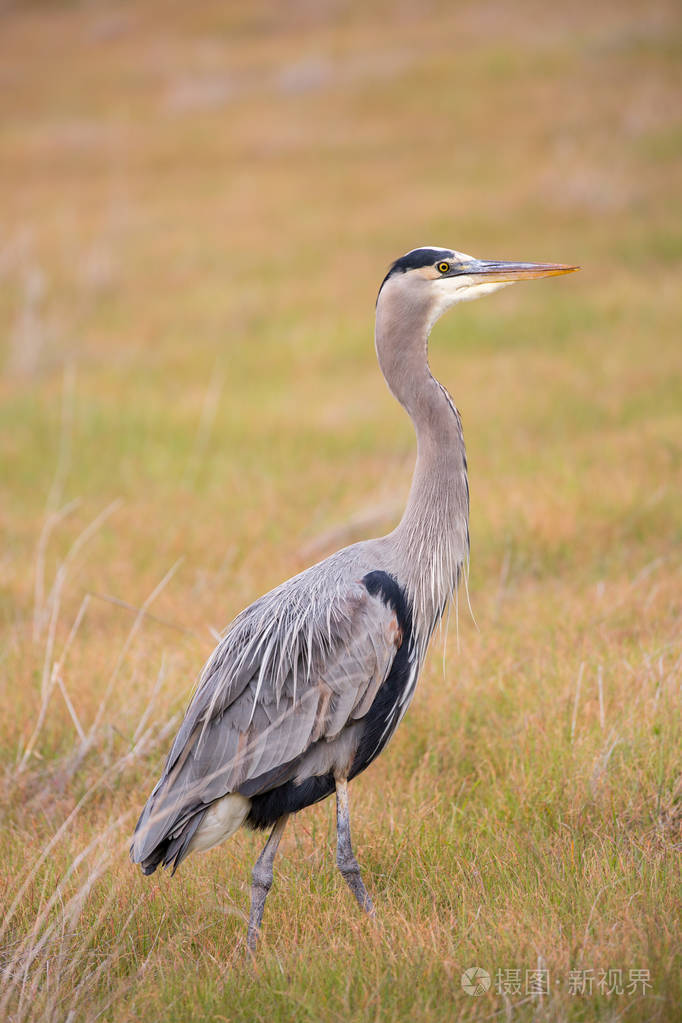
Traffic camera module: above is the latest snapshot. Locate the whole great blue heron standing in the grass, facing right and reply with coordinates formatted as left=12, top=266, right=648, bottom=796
left=131, top=248, right=578, bottom=949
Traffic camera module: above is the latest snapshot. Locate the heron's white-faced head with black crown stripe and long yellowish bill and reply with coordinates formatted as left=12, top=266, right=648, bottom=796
left=377, top=247, right=580, bottom=326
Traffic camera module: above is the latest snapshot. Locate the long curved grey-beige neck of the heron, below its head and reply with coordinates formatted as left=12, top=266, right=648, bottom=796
left=375, top=280, right=468, bottom=638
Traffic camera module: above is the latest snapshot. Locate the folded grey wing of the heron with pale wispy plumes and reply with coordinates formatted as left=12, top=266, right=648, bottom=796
left=131, top=570, right=402, bottom=861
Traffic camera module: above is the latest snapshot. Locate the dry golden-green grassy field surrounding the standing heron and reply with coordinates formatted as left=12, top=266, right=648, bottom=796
left=0, top=0, right=682, bottom=1023
